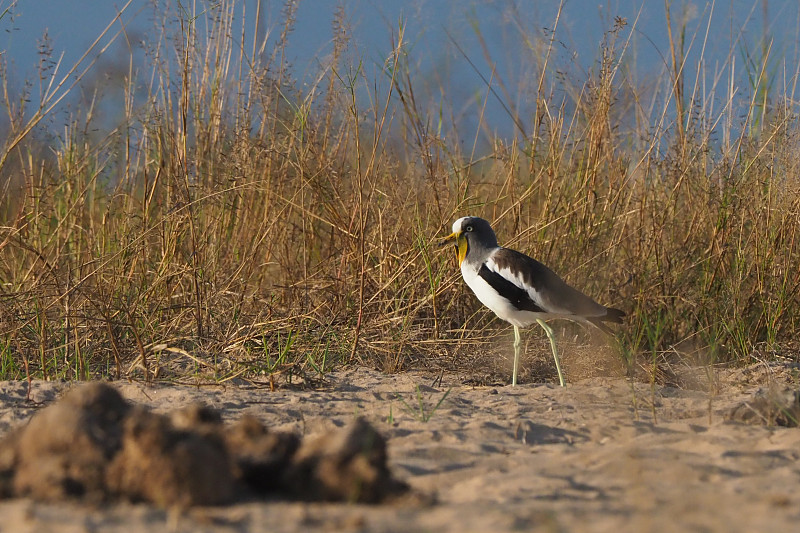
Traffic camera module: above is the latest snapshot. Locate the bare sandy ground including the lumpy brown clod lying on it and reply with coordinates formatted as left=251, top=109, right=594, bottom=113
left=0, top=364, right=800, bottom=532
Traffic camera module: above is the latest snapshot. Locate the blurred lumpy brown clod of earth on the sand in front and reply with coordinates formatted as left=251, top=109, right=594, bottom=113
left=0, top=383, right=409, bottom=507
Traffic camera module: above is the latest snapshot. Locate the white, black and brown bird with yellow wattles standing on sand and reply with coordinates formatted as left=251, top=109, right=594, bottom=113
left=439, top=216, right=625, bottom=387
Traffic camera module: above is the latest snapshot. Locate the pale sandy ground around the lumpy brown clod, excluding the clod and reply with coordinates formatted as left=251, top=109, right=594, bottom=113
left=0, top=365, right=800, bottom=532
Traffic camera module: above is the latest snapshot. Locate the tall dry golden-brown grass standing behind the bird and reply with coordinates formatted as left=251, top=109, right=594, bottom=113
left=0, top=1, right=800, bottom=382
